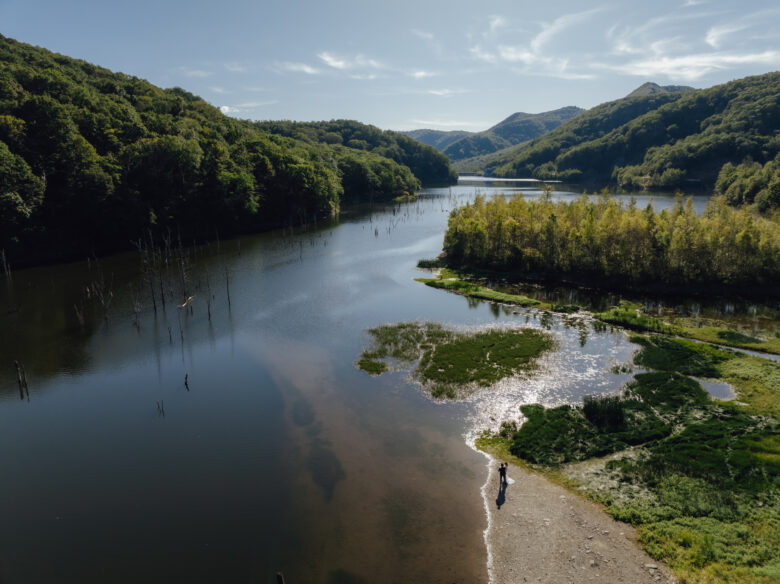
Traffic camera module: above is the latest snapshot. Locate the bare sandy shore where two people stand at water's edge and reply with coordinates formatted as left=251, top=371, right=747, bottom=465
left=482, top=455, right=675, bottom=584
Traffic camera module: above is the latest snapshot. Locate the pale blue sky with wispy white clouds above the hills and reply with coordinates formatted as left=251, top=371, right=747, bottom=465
left=0, top=0, right=780, bottom=131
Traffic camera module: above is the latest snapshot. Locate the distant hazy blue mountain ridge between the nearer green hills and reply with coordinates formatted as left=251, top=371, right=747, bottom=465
left=404, top=106, right=585, bottom=162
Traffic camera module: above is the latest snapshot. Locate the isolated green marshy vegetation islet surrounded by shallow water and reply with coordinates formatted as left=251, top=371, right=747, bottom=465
left=357, top=322, right=555, bottom=399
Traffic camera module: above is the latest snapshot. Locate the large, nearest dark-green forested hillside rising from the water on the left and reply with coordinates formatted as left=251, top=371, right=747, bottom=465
left=0, top=35, right=453, bottom=265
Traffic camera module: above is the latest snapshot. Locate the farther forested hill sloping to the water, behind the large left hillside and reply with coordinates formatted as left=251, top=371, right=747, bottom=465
left=254, top=120, right=458, bottom=186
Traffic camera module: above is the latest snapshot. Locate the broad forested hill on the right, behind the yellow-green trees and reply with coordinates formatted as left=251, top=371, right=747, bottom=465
left=487, top=73, right=780, bottom=193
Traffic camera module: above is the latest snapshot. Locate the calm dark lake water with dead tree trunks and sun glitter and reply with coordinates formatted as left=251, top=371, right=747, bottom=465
left=0, top=184, right=764, bottom=584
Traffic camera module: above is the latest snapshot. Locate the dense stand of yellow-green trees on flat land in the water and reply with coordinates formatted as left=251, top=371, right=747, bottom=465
left=444, top=194, right=780, bottom=294
